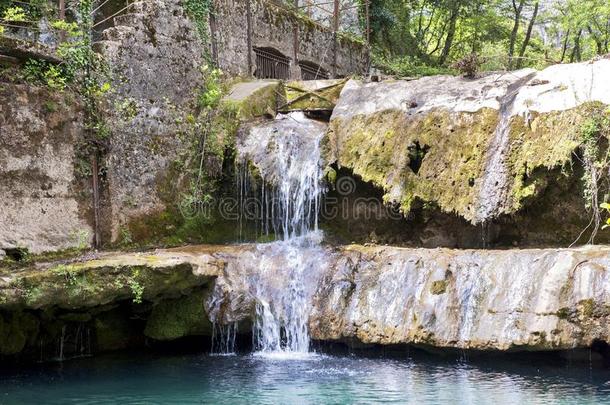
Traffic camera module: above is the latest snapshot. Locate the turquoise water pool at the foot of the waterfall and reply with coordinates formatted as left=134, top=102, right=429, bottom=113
left=0, top=348, right=610, bottom=404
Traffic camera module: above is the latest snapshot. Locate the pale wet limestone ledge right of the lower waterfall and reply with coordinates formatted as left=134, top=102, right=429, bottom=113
left=310, top=246, right=610, bottom=351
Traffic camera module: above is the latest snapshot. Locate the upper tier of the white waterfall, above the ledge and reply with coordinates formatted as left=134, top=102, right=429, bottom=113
left=237, top=112, right=326, bottom=240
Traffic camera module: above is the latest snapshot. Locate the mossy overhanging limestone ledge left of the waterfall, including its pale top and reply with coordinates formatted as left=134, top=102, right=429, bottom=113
left=0, top=248, right=233, bottom=310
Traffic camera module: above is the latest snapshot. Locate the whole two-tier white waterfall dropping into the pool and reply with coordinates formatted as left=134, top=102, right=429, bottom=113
left=209, top=113, right=326, bottom=355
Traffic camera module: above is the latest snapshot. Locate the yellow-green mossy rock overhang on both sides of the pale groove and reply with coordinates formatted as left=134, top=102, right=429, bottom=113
left=325, top=103, right=610, bottom=223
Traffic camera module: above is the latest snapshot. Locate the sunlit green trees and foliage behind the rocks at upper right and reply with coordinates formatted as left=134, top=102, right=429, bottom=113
left=359, top=0, right=610, bottom=76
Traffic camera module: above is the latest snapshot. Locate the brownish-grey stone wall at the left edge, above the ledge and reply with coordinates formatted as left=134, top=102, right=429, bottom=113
left=0, top=82, right=93, bottom=256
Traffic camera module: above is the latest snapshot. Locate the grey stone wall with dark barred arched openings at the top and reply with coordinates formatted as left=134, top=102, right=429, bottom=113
left=212, top=0, right=368, bottom=79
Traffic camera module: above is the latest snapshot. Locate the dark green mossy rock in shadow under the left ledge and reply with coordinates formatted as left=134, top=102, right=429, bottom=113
left=144, top=291, right=212, bottom=340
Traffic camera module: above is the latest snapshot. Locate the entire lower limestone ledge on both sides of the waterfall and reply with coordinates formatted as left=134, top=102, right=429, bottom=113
left=0, top=244, right=610, bottom=354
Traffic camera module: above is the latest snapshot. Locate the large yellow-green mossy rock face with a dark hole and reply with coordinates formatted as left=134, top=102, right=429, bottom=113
left=325, top=109, right=498, bottom=219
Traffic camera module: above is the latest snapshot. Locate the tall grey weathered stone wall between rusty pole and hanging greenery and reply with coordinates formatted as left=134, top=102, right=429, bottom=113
left=98, top=0, right=204, bottom=240
